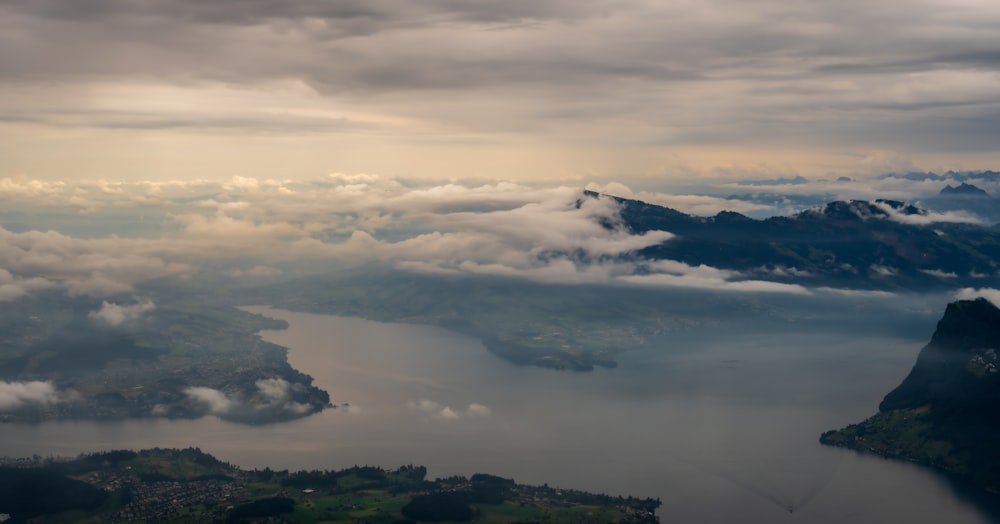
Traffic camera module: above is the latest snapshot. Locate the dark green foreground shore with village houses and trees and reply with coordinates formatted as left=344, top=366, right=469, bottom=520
left=0, top=448, right=660, bottom=524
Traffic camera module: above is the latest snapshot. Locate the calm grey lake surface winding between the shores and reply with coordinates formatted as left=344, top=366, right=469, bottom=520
left=0, top=307, right=997, bottom=523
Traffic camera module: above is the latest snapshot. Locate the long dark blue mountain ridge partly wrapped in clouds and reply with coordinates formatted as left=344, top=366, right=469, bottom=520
left=586, top=192, right=1000, bottom=290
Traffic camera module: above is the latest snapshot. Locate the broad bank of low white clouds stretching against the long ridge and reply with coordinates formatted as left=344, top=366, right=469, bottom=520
left=0, top=174, right=973, bottom=296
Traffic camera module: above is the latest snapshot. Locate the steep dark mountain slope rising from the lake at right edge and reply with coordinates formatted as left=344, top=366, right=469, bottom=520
left=820, top=298, right=1000, bottom=491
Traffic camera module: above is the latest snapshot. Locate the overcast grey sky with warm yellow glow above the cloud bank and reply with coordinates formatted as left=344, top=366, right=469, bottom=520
left=0, top=0, right=1000, bottom=187
